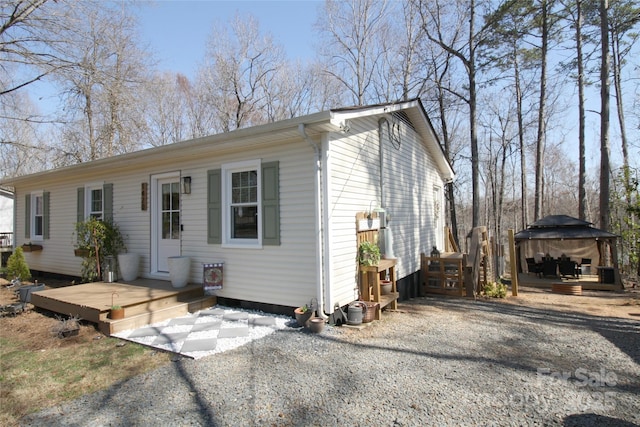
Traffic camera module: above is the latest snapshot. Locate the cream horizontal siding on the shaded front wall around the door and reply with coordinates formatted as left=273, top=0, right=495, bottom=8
left=17, top=139, right=317, bottom=306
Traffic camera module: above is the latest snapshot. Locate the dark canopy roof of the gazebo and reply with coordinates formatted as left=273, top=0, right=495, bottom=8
left=514, top=215, right=618, bottom=241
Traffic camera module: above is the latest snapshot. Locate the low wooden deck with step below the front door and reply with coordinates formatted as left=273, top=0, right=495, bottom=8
left=31, top=279, right=216, bottom=335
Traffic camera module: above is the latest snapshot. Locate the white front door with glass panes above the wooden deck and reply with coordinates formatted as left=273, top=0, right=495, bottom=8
left=152, top=175, right=181, bottom=273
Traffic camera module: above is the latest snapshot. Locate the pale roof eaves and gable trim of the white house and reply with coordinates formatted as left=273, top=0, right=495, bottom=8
left=0, top=99, right=455, bottom=186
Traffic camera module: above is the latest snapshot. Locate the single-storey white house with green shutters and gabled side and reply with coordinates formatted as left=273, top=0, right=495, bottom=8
left=1, top=100, right=454, bottom=314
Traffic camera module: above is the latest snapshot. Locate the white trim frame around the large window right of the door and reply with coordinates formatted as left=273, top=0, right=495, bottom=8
left=221, top=159, right=262, bottom=249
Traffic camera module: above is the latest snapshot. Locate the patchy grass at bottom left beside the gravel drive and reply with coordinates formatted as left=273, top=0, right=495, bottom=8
left=0, top=324, right=170, bottom=426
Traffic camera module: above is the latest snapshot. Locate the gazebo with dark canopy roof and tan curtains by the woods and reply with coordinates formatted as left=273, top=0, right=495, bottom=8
left=514, top=215, right=621, bottom=290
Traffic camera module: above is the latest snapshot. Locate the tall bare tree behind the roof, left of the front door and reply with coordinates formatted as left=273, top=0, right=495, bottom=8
left=55, top=2, right=149, bottom=163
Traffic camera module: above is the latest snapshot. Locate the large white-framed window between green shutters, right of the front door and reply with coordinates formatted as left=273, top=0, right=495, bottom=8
left=223, top=160, right=262, bottom=246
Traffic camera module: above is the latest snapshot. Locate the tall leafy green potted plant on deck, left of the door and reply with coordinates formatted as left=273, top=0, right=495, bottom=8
left=74, top=218, right=126, bottom=282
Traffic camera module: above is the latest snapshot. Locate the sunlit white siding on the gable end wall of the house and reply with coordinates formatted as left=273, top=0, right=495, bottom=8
left=330, top=113, right=443, bottom=305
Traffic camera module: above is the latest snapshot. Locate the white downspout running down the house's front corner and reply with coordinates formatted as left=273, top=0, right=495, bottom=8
left=298, top=123, right=327, bottom=320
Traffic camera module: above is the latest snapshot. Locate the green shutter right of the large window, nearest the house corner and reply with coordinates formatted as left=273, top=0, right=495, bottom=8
left=262, top=162, right=280, bottom=246
